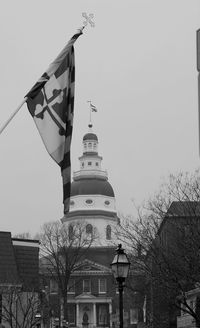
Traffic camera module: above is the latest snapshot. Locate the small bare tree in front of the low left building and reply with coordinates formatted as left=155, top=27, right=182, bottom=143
left=2, top=286, right=40, bottom=328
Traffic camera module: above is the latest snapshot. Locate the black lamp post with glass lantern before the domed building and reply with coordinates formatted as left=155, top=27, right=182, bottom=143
left=111, top=244, right=130, bottom=328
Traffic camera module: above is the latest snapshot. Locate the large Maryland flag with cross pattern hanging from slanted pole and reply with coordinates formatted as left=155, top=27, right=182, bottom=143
left=26, top=30, right=82, bottom=213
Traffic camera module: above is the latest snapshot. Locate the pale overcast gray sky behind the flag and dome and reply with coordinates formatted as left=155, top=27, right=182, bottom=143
left=0, top=0, right=200, bottom=234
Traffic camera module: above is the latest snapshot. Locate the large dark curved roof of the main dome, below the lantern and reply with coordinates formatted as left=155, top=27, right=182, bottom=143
left=71, top=178, right=115, bottom=197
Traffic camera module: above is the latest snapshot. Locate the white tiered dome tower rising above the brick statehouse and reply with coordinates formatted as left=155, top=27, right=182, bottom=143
left=62, top=124, right=118, bottom=246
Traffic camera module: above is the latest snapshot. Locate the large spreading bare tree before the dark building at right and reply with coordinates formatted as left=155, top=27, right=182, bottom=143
left=118, top=170, right=200, bottom=325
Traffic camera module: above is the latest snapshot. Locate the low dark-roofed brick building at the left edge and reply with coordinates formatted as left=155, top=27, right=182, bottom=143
left=0, top=231, right=39, bottom=327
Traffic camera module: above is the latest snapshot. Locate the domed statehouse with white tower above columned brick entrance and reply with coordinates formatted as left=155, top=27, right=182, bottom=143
left=45, top=124, right=145, bottom=328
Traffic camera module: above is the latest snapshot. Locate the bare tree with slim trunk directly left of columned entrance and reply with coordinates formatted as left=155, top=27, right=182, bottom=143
left=40, top=221, right=97, bottom=325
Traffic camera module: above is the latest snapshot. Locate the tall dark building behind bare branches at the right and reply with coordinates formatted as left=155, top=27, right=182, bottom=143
left=146, top=202, right=200, bottom=328
